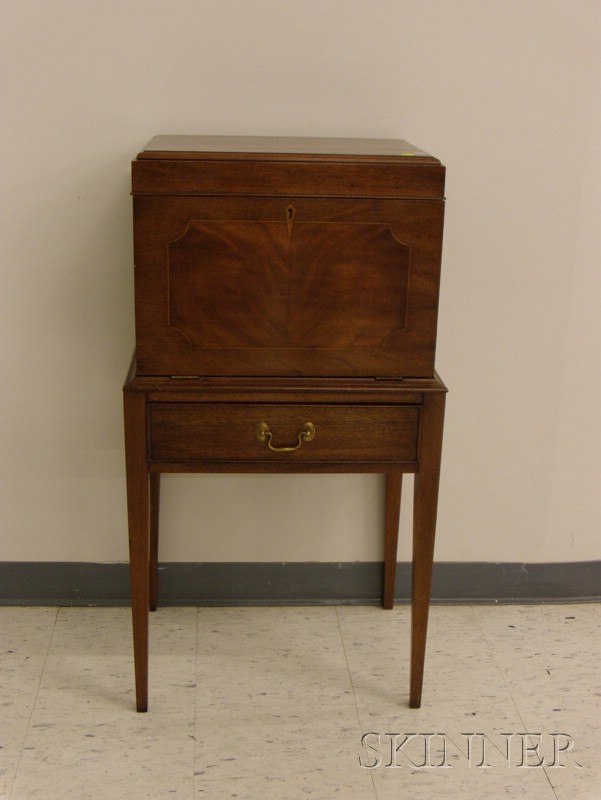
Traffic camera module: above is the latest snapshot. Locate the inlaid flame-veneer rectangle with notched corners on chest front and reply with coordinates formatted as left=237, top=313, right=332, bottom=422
left=167, top=219, right=409, bottom=349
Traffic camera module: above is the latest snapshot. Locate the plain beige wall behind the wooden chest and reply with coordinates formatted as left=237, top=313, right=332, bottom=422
left=0, top=0, right=601, bottom=561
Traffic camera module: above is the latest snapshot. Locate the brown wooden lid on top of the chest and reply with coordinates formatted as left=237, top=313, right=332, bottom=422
left=132, top=136, right=444, bottom=198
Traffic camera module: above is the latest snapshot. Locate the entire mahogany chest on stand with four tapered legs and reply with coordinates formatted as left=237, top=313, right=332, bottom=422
left=124, top=136, right=446, bottom=711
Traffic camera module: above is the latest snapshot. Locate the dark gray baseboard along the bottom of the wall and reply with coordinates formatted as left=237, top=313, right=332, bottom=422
left=0, top=561, right=601, bottom=606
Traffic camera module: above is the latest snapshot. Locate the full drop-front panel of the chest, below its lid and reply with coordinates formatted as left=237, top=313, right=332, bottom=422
left=134, top=197, right=443, bottom=377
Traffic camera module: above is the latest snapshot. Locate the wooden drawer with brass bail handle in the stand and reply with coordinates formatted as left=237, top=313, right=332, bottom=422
left=149, top=402, right=420, bottom=464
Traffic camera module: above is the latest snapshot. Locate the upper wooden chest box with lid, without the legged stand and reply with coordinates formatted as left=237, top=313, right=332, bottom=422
left=133, top=136, right=444, bottom=377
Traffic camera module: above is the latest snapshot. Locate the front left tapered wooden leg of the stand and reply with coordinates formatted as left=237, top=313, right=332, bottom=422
left=124, top=390, right=150, bottom=711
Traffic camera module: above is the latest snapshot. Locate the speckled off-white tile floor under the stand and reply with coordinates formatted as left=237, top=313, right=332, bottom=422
left=0, top=604, right=601, bottom=800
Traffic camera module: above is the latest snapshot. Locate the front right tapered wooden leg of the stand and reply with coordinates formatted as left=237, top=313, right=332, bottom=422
left=409, top=391, right=445, bottom=708
